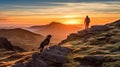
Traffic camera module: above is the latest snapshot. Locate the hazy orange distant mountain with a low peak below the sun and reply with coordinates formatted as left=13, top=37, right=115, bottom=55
left=29, top=22, right=82, bottom=40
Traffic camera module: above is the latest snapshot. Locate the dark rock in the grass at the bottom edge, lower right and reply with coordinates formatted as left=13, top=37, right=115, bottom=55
left=80, top=55, right=104, bottom=67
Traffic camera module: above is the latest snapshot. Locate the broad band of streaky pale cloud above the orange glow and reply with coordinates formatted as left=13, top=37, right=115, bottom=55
left=0, top=1, right=120, bottom=17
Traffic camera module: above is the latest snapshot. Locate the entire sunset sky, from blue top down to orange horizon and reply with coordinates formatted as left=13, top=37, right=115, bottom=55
left=0, top=0, right=120, bottom=25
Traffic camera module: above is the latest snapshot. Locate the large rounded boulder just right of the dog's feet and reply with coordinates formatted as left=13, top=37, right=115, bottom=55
left=40, top=45, right=71, bottom=64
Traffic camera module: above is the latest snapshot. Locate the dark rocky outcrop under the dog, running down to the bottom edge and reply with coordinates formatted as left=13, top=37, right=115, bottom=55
left=13, top=46, right=71, bottom=67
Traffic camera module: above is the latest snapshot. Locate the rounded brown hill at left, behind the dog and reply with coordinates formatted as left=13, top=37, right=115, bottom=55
left=0, top=28, right=45, bottom=50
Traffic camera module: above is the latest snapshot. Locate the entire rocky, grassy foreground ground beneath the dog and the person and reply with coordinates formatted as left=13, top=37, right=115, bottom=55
left=0, top=20, right=120, bottom=67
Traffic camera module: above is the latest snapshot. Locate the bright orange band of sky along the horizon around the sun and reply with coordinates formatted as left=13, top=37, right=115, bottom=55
left=1, top=14, right=119, bottom=25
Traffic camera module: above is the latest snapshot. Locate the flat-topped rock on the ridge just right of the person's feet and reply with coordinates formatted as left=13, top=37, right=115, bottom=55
left=88, top=25, right=109, bottom=32
